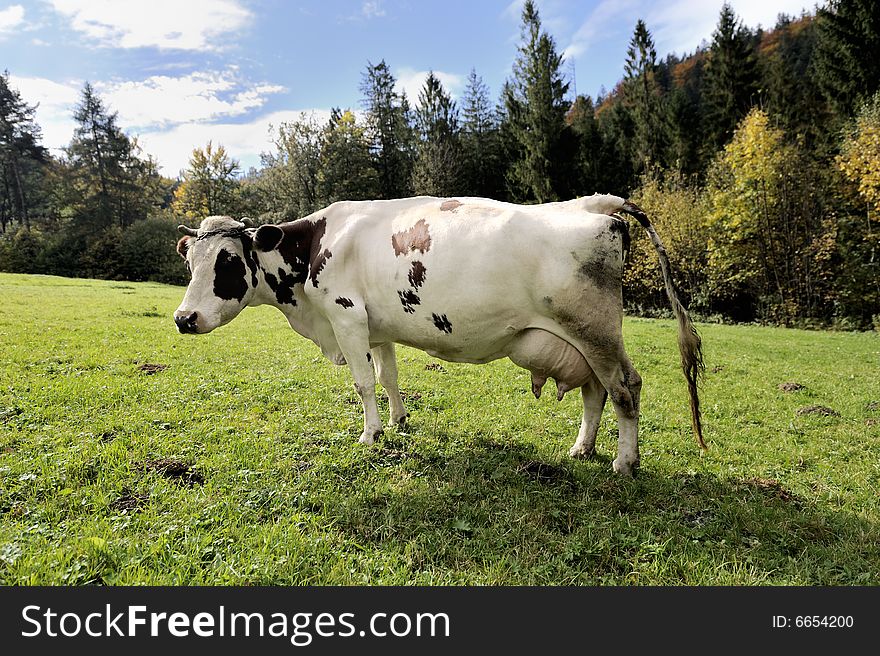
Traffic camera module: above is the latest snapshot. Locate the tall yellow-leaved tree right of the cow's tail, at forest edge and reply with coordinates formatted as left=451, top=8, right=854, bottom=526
left=707, top=108, right=833, bottom=324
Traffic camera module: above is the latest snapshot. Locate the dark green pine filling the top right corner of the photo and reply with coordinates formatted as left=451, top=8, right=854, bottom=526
left=815, top=0, right=880, bottom=117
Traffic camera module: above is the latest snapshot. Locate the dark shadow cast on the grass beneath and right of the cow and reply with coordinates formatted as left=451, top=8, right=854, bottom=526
left=328, top=438, right=880, bottom=585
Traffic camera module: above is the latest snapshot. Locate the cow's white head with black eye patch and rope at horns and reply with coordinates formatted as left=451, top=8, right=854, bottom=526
left=174, top=216, right=266, bottom=333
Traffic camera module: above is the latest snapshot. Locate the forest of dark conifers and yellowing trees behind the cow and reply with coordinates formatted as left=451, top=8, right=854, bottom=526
left=0, top=0, right=880, bottom=330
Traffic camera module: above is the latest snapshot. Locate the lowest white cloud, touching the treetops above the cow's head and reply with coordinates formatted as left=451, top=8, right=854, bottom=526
left=138, top=109, right=330, bottom=177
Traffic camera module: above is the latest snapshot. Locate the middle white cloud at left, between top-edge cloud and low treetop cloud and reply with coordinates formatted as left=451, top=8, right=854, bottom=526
left=95, top=69, right=284, bottom=129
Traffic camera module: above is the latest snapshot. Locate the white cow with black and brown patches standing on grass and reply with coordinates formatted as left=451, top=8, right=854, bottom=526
left=174, top=195, right=705, bottom=476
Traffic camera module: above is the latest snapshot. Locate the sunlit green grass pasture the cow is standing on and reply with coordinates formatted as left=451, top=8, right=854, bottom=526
left=0, top=274, right=880, bottom=585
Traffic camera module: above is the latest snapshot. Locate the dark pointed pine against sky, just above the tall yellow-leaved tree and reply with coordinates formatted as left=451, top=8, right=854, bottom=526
left=705, top=3, right=758, bottom=153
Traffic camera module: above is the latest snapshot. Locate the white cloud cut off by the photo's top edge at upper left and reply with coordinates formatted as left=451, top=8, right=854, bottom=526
left=50, top=0, right=251, bottom=50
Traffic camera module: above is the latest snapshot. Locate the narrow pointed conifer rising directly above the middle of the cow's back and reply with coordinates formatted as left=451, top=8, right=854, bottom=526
left=412, top=72, right=462, bottom=196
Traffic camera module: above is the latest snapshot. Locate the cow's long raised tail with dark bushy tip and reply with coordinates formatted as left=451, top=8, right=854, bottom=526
left=621, top=201, right=706, bottom=449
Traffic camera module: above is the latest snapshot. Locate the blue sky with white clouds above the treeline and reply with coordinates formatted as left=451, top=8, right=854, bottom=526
left=0, top=0, right=814, bottom=177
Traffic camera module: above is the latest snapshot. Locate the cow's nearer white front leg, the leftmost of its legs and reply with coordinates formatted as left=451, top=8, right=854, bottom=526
left=332, top=308, right=382, bottom=444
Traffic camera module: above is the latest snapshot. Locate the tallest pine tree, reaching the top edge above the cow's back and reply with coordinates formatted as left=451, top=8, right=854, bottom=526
left=503, top=0, right=573, bottom=203
